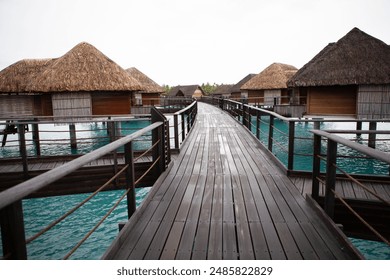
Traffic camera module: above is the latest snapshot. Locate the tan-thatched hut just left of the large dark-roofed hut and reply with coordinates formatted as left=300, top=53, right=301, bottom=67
left=241, top=63, right=298, bottom=106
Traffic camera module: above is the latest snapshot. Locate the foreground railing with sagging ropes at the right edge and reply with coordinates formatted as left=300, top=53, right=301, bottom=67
left=312, top=130, right=390, bottom=245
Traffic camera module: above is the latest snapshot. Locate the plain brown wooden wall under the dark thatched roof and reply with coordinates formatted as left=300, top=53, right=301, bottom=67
left=307, top=85, right=357, bottom=115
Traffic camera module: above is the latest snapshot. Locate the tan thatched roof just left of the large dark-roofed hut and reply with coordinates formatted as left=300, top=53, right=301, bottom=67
left=241, top=63, right=298, bottom=90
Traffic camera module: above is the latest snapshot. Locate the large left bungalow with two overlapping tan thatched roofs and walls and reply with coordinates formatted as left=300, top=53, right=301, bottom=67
left=0, top=43, right=142, bottom=120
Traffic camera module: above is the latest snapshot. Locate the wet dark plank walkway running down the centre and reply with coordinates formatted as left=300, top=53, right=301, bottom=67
left=103, top=103, right=360, bottom=259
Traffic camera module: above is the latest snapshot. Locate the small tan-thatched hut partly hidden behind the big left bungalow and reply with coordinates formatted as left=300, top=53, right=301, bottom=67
left=126, top=67, right=165, bottom=107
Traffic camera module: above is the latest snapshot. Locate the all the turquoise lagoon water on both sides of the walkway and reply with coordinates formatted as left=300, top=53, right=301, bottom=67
left=0, top=120, right=390, bottom=260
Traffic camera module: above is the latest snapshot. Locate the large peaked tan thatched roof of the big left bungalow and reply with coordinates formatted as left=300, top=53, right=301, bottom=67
left=32, top=42, right=142, bottom=92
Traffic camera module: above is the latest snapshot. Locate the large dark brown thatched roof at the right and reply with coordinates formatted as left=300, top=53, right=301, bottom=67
left=288, top=28, right=390, bottom=86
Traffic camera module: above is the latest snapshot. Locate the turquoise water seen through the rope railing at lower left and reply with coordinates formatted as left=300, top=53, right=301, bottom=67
left=0, top=188, right=150, bottom=260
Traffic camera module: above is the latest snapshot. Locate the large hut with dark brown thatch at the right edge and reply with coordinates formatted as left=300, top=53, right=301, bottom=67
left=288, top=28, right=390, bottom=119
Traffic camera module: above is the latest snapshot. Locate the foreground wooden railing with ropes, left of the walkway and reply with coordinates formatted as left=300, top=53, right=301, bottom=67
left=0, top=106, right=170, bottom=259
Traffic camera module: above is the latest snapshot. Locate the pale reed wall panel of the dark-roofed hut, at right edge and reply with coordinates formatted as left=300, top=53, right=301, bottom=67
left=357, top=85, right=390, bottom=119
